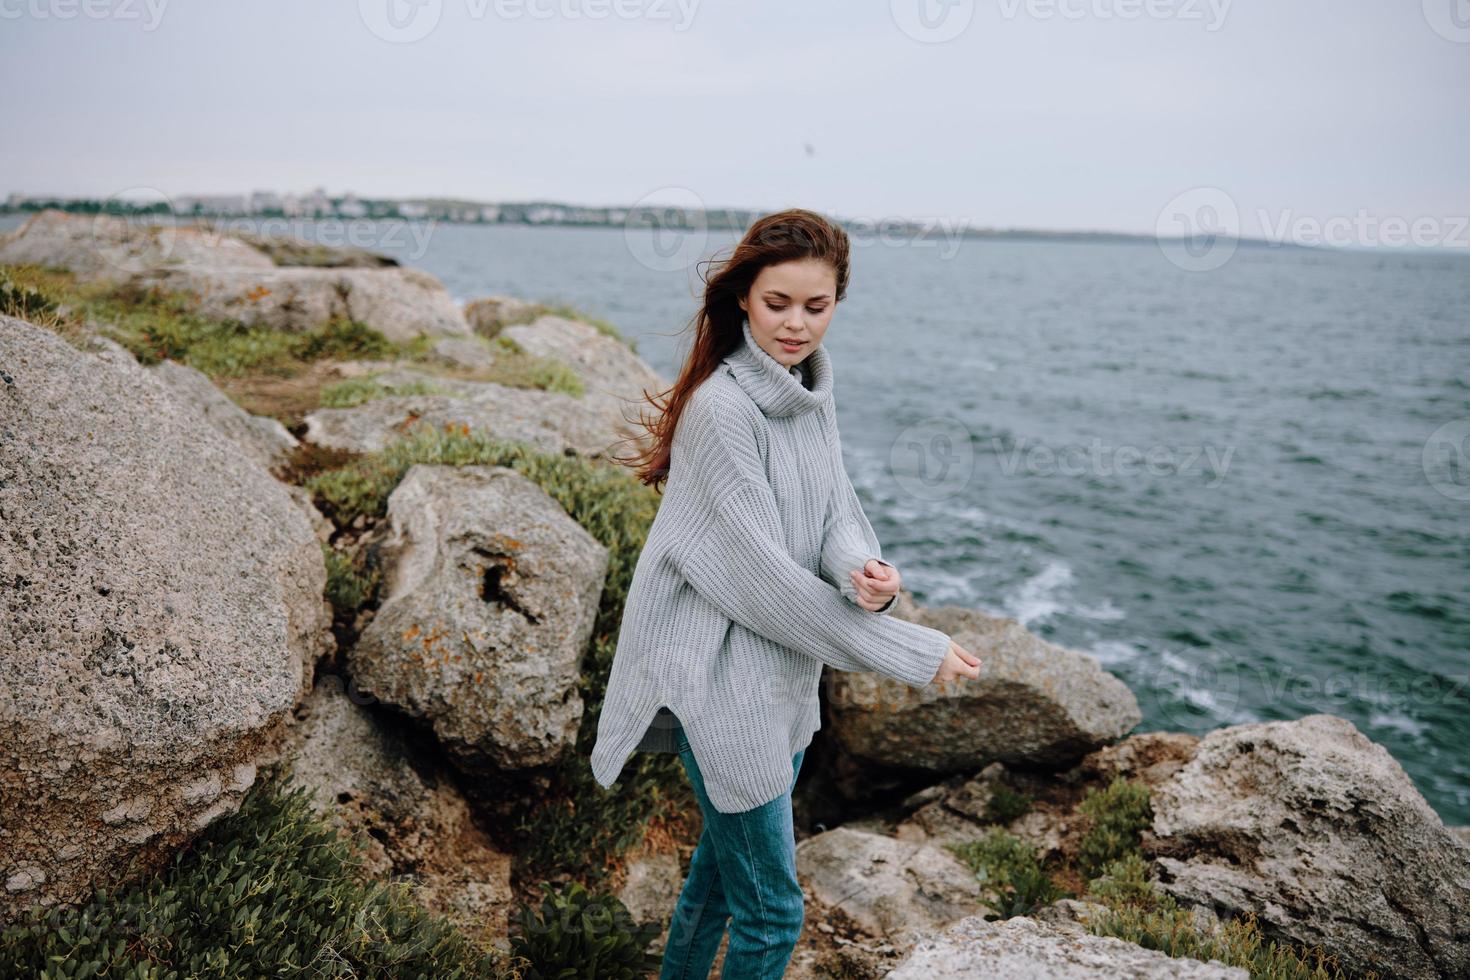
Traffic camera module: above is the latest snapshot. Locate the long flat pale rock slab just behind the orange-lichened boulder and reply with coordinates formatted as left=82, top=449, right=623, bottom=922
left=303, top=370, right=617, bottom=458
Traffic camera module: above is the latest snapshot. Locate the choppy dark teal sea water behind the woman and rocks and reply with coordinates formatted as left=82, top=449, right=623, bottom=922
left=14, top=218, right=1470, bottom=824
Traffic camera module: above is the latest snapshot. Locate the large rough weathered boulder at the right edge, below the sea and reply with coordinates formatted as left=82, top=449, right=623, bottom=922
left=1145, top=714, right=1470, bottom=977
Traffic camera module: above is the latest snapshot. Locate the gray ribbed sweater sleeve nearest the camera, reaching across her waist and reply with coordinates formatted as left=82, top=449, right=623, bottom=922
left=673, top=390, right=950, bottom=688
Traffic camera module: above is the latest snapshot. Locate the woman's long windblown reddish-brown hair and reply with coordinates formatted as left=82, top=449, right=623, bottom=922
left=613, top=207, right=851, bottom=489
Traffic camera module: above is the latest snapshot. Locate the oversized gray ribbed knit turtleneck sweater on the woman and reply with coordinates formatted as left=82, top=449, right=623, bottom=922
left=591, top=323, right=950, bottom=813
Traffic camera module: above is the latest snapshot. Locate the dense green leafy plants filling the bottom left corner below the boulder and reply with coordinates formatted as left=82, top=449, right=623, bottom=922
left=0, top=770, right=523, bottom=980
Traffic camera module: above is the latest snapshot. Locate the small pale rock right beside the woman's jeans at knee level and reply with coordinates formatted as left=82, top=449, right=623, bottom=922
left=797, top=827, right=980, bottom=942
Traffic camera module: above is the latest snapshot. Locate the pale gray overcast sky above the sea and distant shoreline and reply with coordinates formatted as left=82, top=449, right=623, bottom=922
left=0, top=0, right=1470, bottom=244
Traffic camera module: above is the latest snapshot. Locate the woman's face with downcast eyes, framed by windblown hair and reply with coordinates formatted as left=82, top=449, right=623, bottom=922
left=739, top=259, right=836, bottom=367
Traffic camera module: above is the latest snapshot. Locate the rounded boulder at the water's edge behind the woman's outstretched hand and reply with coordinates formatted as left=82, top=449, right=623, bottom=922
left=826, top=594, right=1142, bottom=782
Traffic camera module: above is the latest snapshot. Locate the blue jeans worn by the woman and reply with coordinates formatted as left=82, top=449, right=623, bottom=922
left=659, top=717, right=806, bottom=980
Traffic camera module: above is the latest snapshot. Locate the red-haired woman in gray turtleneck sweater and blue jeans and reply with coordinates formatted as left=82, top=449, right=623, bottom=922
left=591, top=209, right=980, bottom=979
